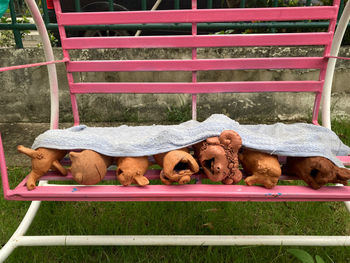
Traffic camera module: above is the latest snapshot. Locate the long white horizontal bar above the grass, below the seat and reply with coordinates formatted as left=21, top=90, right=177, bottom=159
left=17, top=235, right=350, bottom=249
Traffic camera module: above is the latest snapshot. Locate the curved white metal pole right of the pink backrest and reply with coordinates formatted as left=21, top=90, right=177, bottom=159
left=322, top=1, right=350, bottom=129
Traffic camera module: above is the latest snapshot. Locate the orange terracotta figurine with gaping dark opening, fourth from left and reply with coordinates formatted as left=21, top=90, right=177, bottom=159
left=154, top=148, right=199, bottom=184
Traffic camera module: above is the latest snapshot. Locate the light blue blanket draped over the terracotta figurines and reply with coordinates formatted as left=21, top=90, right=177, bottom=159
left=32, top=114, right=350, bottom=167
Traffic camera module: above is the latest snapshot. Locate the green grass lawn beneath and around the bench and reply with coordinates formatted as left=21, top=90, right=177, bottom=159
left=0, top=121, right=350, bottom=263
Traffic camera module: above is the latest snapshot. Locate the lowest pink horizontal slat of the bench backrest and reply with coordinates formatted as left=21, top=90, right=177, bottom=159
left=70, top=81, right=323, bottom=94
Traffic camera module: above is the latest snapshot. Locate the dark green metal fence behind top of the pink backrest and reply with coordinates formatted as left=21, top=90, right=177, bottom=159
left=0, top=0, right=345, bottom=48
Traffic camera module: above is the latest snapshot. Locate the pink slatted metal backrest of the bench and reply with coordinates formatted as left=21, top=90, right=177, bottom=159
left=54, top=0, right=339, bottom=124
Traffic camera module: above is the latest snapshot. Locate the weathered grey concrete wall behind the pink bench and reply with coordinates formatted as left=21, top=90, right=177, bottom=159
left=0, top=47, right=350, bottom=163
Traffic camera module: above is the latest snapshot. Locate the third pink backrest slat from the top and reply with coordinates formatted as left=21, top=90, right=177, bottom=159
left=67, top=57, right=324, bottom=72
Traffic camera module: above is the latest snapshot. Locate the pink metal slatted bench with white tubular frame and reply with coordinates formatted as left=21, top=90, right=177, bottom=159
left=0, top=0, right=350, bottom=259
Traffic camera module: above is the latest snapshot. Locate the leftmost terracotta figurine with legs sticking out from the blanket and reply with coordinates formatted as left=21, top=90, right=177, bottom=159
left=17, top=145, right=67, bottom=190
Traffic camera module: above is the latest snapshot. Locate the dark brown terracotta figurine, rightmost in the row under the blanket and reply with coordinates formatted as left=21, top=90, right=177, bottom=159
left=282, top=156, right=350, bottom=189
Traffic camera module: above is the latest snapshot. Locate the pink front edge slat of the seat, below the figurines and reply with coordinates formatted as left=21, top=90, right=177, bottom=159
left=7, top=184, right=350, bottom=202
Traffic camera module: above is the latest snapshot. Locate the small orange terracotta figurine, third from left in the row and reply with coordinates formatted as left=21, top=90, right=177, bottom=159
left=117, top=156, right=149, bottom=186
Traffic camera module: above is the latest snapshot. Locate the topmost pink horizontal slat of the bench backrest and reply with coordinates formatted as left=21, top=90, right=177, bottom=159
left=57, top=6, right=337, bottom=25
